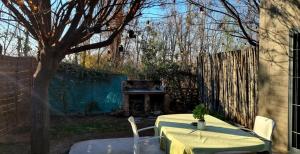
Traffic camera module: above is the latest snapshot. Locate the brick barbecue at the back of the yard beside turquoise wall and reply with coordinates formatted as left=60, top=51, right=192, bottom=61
left=122, top=80, right=169, bottom=116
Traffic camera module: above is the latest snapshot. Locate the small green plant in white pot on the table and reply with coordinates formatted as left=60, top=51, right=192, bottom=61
left=193, top=104, right=206, bottom=130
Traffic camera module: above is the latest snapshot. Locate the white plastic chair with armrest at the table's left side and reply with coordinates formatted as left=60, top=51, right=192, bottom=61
left=128, top=116, right=164, bottom=154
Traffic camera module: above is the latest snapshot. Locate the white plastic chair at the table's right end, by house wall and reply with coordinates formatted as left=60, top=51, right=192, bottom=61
left=217, top=116, right=275, bottom=154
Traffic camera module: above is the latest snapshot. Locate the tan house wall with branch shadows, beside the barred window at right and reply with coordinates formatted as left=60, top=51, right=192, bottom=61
left=258, top=0, right=300, bottom=153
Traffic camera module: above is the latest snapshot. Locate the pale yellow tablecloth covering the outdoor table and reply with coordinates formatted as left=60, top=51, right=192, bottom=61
left=155, top=114, right=264, bottom=154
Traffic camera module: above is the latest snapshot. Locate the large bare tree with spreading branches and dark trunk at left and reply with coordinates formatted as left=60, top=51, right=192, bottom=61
left=1, top=0, right=144, bottom=154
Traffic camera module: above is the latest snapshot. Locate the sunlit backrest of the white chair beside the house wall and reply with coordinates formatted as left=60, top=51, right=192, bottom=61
left=253, top=116, right=275, bottom=141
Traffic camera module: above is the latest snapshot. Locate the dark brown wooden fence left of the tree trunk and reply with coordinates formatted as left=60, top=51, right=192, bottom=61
left=0, top=56, right=35, bottom=135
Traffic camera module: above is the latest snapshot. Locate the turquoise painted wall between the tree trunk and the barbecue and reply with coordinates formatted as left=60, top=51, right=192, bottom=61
left=49, top=73, right=127, bottom=115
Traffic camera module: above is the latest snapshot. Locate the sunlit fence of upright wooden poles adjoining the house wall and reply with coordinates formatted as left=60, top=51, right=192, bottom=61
left=197, top=48, right=258, bottom=127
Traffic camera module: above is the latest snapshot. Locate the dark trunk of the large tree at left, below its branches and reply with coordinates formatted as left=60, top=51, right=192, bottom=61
left=31, top=49, right=60, bottom=154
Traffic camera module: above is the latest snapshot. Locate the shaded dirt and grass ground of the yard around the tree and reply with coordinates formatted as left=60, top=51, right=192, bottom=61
left=0, top=115, right=155, bottom=154
